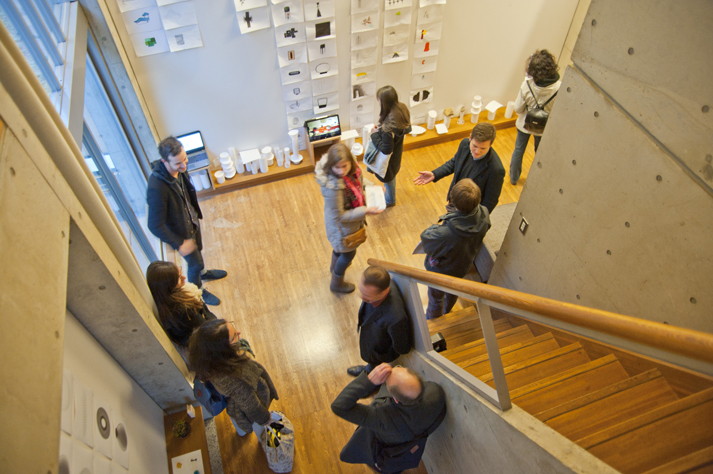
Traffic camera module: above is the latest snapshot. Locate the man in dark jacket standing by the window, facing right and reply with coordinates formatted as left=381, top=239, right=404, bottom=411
left=146, top=137, right=228, bottom=306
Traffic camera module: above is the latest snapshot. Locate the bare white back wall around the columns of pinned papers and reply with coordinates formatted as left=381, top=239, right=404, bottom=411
left=100, top=0, right=578, bottom=154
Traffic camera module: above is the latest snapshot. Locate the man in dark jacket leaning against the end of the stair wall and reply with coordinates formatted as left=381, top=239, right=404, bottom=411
left=347, top=266, right=412, bottom=377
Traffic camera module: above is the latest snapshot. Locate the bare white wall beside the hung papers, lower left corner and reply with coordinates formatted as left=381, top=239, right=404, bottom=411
left=64, top=311, right=168, bottom=474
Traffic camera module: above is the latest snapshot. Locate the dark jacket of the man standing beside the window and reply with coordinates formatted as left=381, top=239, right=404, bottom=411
left=146, top=160, right=203, bottom=250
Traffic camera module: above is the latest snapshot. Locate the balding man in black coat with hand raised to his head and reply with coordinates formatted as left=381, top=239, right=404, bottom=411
left=332, top=364, right=446, bottom=467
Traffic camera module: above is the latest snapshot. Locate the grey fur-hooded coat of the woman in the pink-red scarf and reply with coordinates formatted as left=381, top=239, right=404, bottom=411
left=314, top=155, right=368, bottom=253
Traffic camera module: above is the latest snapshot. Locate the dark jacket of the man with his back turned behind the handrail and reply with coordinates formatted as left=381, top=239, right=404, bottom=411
left=421, top=205, right=490, bottom=278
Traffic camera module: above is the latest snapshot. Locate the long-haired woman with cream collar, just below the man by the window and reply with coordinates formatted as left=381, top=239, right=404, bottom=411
left=146, top=261, right=216, bottom=351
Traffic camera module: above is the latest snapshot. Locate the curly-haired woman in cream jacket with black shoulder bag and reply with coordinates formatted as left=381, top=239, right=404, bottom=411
left=510, top=49, right=562, bottom=186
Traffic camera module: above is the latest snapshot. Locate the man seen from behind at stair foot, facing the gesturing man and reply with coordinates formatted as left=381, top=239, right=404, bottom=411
left=421, top=178, right=490, bottom=319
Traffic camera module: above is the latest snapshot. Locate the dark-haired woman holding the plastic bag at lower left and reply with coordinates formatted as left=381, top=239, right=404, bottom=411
left=188, top=319, right=278, bottom=438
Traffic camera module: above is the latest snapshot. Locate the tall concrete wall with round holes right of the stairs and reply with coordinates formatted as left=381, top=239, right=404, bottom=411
left=490, top=0, right=713, bottom=332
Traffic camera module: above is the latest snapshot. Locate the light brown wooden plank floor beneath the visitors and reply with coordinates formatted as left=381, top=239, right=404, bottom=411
left=201, top=128, right=533, bottom=474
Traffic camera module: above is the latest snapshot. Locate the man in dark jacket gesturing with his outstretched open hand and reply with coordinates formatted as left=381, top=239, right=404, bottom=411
left=413, top=123, right=505, bottom=213
